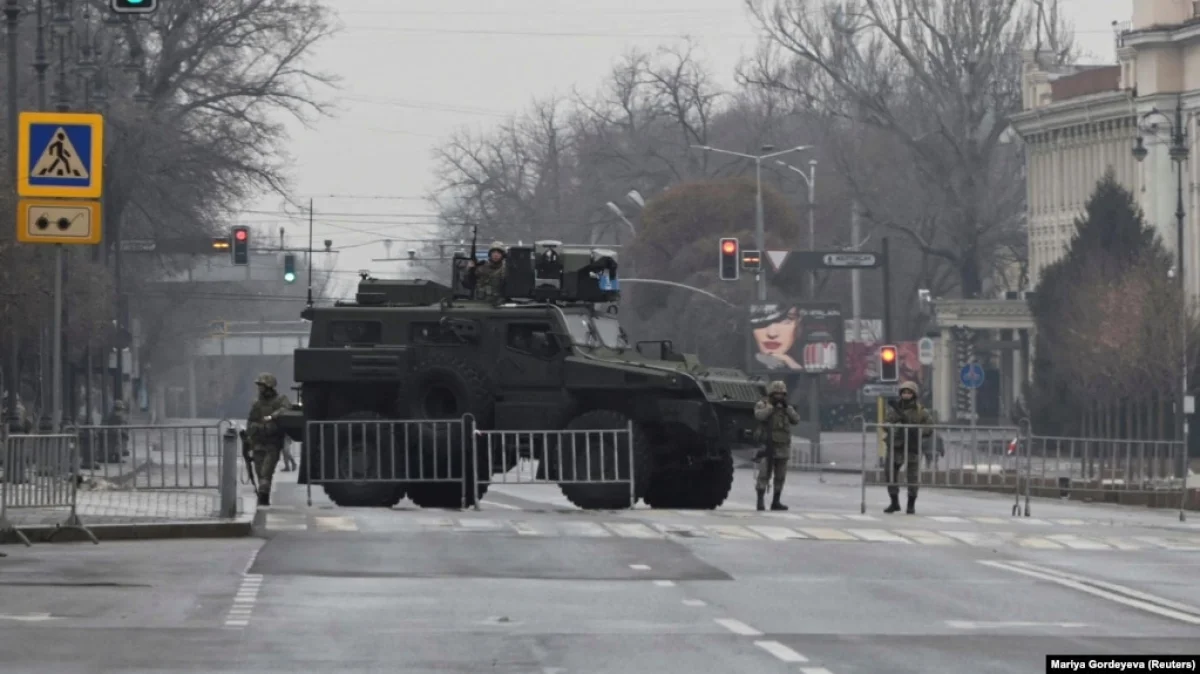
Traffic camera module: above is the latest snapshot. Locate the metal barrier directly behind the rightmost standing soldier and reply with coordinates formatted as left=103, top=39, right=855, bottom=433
left=862, top=423, right=1028, bottom=516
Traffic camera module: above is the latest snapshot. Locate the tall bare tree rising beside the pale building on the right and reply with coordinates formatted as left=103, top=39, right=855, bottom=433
left=740, top=0, right=1069, bottom=297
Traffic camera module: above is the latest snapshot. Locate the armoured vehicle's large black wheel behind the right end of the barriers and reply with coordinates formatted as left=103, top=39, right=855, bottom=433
left=551, top=410, right=653, bottom=510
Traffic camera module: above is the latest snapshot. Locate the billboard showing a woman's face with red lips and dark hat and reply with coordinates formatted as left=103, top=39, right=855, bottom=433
left=746, top=302, right=845, bottom=374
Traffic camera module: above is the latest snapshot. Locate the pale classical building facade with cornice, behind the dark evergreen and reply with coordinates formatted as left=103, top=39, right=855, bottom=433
left=1013, top=0, right=1200, bottom=301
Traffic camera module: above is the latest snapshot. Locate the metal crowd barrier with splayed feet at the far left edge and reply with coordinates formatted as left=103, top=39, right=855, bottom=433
left=0, top=433, right=100, bottom=546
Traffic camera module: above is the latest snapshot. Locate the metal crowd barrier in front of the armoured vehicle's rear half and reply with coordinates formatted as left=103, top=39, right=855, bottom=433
left=302, top=415, right=474, bottom=507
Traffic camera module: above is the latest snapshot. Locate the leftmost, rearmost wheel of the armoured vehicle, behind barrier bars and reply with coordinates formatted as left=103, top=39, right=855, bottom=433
left=319, top=411, right=404, bottom=507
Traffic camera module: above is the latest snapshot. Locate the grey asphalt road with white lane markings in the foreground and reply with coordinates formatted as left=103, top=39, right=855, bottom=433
left=0, top=471, right=1200, bottom=674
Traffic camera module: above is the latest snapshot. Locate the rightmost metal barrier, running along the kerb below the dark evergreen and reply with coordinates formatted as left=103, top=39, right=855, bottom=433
left=1026, top=435, right=1187, bottom=508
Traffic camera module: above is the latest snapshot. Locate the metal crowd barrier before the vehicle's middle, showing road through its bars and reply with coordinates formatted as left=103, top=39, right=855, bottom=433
left=472, top=422, right=637, bottom=510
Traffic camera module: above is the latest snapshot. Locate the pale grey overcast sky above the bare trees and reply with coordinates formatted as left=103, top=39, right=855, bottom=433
left=241, top=0, right=1133, bottom=282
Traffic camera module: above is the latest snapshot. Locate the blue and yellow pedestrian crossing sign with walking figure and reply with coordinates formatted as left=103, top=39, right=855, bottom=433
left=17, top=113, right=104, bottom=199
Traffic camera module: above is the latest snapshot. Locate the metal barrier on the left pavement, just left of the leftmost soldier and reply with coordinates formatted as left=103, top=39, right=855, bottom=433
left=78, top=421, right=232, bottom=489
